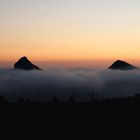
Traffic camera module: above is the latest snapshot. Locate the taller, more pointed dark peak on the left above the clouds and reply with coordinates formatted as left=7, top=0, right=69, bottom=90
left=14, top=56, right=41, bottom=70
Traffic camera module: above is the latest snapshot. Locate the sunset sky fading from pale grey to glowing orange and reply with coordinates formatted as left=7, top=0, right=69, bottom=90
left=0, top=0, right=140, bottom=67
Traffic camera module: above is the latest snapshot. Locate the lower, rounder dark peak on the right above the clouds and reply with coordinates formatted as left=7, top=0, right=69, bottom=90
left=109, top=60, right=138, bottom=70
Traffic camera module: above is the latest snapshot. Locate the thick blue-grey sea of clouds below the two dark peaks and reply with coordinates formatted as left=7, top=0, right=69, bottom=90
left=0, top=68, right=140, bottom=102
